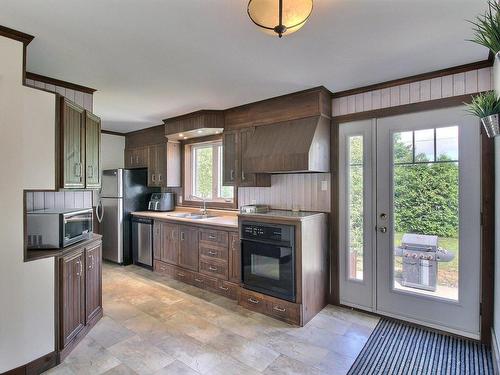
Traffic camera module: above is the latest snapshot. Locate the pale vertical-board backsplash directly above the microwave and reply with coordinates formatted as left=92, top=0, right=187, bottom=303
left=25, top=190, right=92, bottom=212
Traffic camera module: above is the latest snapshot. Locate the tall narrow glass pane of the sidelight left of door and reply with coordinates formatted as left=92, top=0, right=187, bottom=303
left=347, top=135, right=364, bottom=281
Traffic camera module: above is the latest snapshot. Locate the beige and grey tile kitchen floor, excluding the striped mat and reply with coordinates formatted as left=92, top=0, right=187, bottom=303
left=46, top=264, right=378, bottom=375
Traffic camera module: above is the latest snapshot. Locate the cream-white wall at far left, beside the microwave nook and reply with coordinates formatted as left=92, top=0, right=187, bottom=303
left=0, top=37, right=55, bottom=373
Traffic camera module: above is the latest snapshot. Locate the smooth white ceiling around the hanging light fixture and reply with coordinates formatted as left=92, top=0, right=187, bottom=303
left=0, top=0, right=487, bottom=132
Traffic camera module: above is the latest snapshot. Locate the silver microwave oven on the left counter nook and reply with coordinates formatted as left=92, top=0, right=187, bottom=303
left=26, top=208, right=93, bottom=249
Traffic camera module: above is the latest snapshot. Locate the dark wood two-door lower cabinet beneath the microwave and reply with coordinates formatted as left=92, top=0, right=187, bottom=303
left=56, top=235, right=102, bottom=361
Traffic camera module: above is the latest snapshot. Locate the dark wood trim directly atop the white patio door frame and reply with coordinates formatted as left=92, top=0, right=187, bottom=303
left=332, top=94, right=473, bottom=124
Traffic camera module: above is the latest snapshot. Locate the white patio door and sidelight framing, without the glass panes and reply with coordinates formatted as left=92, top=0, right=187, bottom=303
left=339, top=106, right=481, bottom=339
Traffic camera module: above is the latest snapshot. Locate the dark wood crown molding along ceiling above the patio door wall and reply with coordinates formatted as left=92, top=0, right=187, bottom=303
left=332, top=58, right=493, bottom=99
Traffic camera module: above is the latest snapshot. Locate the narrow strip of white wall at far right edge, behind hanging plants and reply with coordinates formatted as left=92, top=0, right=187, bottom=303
left=493, top=59, right=500, bottom=352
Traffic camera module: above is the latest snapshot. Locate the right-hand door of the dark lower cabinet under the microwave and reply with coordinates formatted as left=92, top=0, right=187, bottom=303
left=85, top=243, right=102, bottom=322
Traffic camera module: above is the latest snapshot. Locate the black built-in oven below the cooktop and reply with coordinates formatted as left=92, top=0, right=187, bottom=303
left=241, top=221, right=295, bottom=302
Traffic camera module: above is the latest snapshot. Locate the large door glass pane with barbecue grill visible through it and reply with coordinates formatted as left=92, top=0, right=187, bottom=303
left=392, top=126, right=459, bottom=300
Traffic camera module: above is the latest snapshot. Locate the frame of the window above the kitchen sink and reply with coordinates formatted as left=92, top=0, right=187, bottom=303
left=181, top=135, right=238, bottom=209
